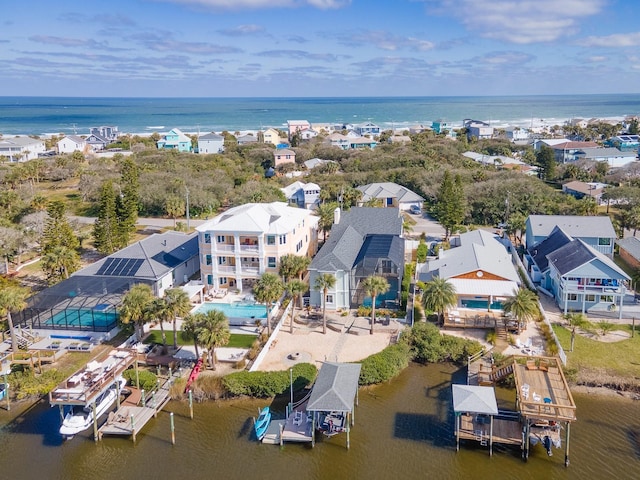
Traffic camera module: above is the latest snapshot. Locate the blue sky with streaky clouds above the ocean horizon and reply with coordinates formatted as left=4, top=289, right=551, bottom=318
left=0, top=0, right=640, bottom=97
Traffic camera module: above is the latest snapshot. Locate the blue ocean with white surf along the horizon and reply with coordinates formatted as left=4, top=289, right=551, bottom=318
left=0, top=94, right=640, bottom=136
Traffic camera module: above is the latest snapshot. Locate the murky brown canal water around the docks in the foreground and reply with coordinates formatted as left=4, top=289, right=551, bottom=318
left=0, top=365, right=640, bottom=480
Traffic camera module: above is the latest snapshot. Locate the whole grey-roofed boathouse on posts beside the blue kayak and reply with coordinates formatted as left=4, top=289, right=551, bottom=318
left=307, top=362, right=361, bottom=449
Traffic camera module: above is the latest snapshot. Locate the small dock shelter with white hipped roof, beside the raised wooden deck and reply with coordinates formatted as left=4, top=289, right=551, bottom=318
left=451, top=385, right=498, bottom=455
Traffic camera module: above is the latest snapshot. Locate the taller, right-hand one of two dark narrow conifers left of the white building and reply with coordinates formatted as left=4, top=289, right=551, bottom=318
left=116, top=158, right=140, bottom=248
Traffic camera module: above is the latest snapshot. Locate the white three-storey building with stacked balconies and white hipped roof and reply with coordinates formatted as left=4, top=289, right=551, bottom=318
left=197, top=202, right=318, bottom=291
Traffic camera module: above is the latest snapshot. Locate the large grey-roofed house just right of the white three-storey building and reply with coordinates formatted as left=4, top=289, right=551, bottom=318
left=309, top=207, right=404, bottom=309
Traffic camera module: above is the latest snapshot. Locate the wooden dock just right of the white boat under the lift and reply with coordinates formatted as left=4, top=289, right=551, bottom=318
left=98, top=374, right=179, bottom=441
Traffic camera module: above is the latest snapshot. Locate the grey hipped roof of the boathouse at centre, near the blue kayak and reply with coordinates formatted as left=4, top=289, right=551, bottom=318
left=307, top=362, right=361, bottom=412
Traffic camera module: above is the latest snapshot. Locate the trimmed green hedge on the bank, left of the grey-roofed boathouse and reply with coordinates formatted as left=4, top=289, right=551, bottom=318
left=223, top=363, right=318, bottom=398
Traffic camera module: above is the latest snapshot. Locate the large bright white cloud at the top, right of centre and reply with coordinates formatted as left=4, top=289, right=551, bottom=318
left=428, top=0, right=605, bottom=44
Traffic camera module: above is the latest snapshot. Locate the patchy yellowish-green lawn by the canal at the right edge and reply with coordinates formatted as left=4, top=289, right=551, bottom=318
left=553, top=322, right=640, bottom=377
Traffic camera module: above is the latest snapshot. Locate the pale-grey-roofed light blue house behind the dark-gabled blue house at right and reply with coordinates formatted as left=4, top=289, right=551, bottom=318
left=526, top=215, right=617, bottom=257
